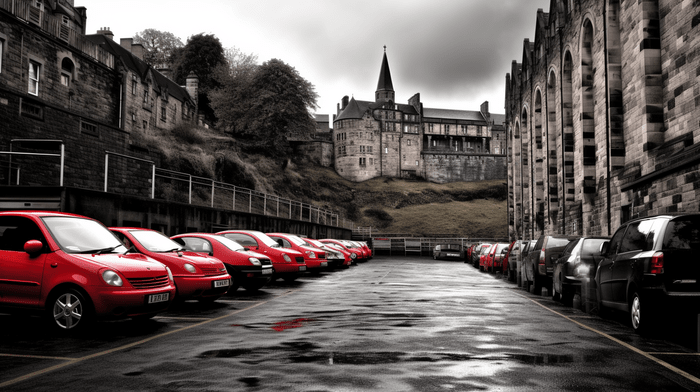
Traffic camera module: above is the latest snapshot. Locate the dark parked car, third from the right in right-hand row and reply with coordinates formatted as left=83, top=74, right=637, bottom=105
left=521, top=235, right=579, bottom=294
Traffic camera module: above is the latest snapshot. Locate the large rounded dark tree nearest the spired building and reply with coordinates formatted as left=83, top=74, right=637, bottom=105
left=213, top=59, right=318, bottom=154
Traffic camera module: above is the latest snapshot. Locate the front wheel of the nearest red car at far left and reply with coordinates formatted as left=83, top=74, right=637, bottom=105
left=46, top=289, right=92, bottom=332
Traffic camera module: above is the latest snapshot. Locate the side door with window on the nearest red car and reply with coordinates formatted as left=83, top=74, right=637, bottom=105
left=0, top=216, right=47, bottom=306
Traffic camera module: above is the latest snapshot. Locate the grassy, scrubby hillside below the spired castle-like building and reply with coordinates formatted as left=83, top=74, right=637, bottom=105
left=140, top=128, right=507, bottom=238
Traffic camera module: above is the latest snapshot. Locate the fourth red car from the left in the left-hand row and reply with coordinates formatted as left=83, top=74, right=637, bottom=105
left=216, top=230, right=306, bottom=282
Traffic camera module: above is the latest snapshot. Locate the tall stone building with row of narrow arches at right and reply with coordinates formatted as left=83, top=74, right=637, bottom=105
left=506, top=0, right=700, bottom=238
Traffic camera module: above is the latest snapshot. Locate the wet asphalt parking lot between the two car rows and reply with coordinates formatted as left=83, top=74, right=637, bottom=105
left=0, top=256, right=700, bottom=391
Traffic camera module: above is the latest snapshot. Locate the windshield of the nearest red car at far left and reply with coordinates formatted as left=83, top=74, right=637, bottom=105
left=42, top=216, right=126, bottom=253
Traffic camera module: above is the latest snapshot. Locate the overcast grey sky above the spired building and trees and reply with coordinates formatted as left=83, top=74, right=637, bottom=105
left=75, top=0, right=550, bottom=115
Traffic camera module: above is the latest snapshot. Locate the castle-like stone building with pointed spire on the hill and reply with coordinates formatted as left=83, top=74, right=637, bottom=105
left=333, top=49, right=506, bottom=183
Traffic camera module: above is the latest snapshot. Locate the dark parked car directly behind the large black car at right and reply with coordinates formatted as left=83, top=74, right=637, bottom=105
left=552, top=237, right=610, bottom=305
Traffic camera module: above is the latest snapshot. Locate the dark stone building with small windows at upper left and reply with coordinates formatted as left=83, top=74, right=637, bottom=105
left=0, top=0, right=197, bottom=193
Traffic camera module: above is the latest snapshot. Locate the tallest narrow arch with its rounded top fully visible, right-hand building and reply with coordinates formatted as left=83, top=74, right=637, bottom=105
left=579, top=18, right=598, bottom=195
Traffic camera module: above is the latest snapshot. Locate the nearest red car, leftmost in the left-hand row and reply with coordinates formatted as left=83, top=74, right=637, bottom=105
left=0, top=211, right=175, bottom=331
